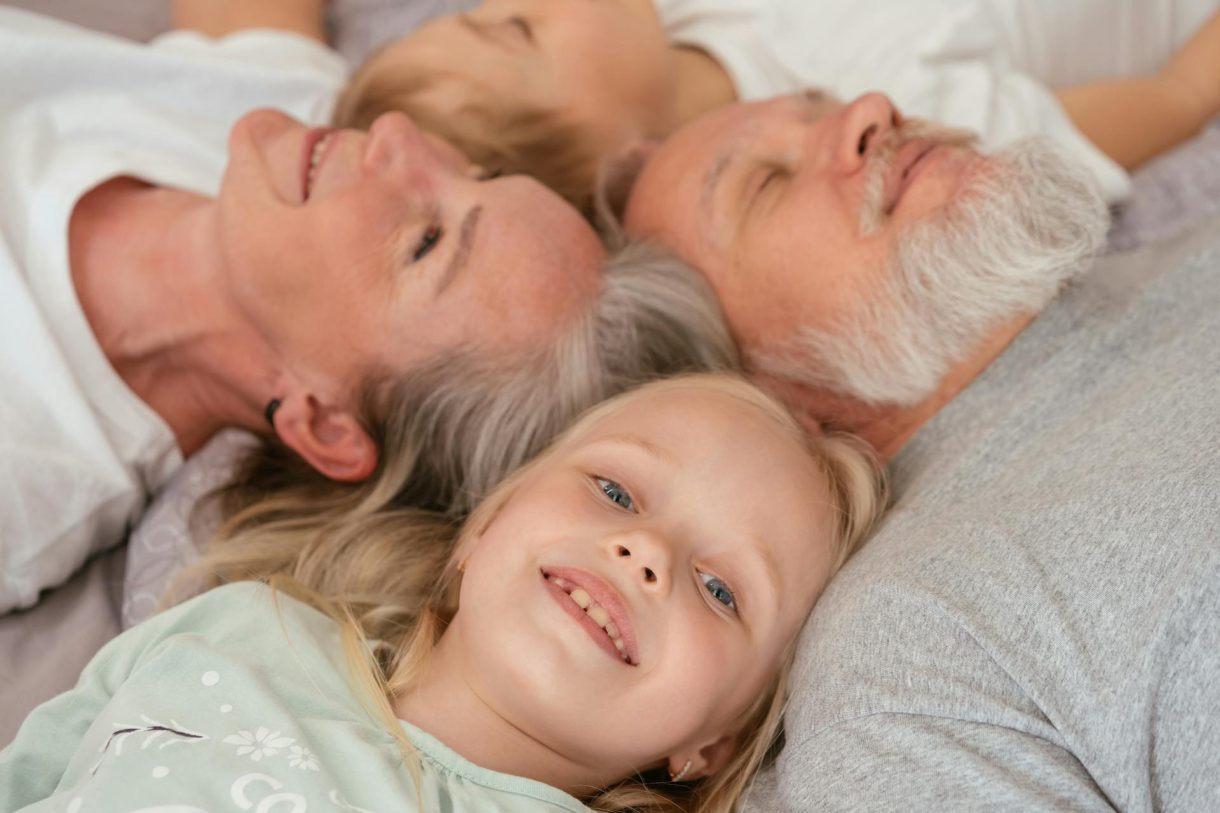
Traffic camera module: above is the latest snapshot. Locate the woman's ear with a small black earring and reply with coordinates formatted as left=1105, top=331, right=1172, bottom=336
left=272, top=393, right=377, bottom=482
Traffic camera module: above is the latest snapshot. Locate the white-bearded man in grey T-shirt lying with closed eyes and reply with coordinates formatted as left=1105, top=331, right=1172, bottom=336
left=626, top=94, right=1220, bottom=811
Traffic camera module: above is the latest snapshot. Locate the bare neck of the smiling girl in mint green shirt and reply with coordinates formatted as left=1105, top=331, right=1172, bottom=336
left=392, top=627, right=610, bottom=796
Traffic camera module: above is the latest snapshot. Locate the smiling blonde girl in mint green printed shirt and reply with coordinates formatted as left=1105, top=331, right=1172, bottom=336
left=0, top=376, right=882, bottom=813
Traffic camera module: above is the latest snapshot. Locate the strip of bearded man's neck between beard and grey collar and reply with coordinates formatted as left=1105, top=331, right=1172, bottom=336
left=766, top=314, right=1036, bottom=461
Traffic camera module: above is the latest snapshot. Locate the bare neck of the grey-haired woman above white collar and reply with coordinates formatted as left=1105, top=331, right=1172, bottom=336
left=68, top=178, right=279, bottom=454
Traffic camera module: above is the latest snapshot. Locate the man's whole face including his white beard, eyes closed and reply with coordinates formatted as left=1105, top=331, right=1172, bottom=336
left=626, top=94, right=1107, bottom=405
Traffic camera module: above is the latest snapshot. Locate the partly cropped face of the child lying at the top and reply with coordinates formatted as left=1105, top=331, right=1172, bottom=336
left=375, top=0, right=673, bottom=139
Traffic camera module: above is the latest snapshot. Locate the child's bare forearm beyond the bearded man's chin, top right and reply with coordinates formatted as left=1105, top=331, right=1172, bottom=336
left=1055, top=13, right=1220, bottom=170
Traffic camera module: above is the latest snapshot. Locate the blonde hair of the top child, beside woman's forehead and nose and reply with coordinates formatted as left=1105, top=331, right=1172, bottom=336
left=333, top=48, right=601, bottom=211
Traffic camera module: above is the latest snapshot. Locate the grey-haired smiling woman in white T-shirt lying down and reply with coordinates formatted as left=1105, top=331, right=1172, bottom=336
left=0, top=10, right=732, bottom=610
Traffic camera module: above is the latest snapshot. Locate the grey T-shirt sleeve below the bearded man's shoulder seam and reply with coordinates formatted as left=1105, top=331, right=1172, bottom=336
left=777, top=713, right=1114, bottom=813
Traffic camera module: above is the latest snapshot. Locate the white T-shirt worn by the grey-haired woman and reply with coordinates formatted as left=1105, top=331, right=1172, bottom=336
left=0, top=7, right=345, bottom=612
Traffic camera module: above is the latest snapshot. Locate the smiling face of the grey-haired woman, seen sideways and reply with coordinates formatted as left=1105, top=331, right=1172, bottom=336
left=218, top=110, right=604, bottom=400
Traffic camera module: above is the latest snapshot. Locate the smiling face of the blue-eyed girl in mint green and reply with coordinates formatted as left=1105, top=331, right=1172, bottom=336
left=445, top=383, right=834, bottom=784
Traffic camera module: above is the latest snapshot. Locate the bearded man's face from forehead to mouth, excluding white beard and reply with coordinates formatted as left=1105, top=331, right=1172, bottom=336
left=626, top=94, right=986, bottom=349
